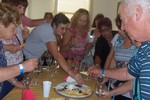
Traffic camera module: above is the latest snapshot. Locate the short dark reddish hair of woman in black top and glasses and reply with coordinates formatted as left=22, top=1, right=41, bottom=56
left=98, top=17, right=112, bottom=31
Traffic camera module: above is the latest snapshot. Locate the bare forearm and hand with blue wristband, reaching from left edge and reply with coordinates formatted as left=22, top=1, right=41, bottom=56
left=0, top=58, right=38, bottom=82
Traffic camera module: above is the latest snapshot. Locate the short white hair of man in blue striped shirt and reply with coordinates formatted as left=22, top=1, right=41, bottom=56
left=121, top=0, right=150, bottom=14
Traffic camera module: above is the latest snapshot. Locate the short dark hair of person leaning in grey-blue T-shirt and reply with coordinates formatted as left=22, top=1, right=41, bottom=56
left=51, top=13, right=70, bottom=26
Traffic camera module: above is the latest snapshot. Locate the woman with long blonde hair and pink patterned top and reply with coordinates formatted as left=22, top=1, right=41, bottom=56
left=60, top=9, right=89, bottom=68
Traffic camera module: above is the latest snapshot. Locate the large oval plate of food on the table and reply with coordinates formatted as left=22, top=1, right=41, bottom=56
left=55, top=82, right=93, bottom=98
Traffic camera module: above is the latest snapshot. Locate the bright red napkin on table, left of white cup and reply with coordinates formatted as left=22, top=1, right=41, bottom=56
left=22, top=89, right=35, bottom=100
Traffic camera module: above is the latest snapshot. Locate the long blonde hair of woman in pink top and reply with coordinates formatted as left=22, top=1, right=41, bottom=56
left=71, top=8, right=90, bottom=29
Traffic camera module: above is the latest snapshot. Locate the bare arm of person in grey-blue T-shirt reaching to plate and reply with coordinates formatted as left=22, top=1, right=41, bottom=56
left=46, top=42, right=83, bottom=84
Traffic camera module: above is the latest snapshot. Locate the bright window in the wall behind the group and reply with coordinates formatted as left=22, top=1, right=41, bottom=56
left=54, top=0, right=91, bottom=18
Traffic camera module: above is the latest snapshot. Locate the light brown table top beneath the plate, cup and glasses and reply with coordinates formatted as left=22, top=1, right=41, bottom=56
left=3, top=68, right=110, bottom=100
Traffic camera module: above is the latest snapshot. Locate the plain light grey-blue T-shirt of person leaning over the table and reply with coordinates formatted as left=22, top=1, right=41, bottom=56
left=23, top=23, right=56, bottom=58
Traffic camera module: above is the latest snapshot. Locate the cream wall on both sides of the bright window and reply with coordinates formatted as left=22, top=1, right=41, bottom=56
left=0, top=0, right=120, bottom=29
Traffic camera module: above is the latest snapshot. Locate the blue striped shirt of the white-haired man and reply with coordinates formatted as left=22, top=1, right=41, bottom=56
left=128, top=41, right=150, bottom=100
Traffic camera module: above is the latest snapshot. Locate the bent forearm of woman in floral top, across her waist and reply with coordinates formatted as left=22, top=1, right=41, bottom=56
left=4, top=44, right=23, bottom=53
